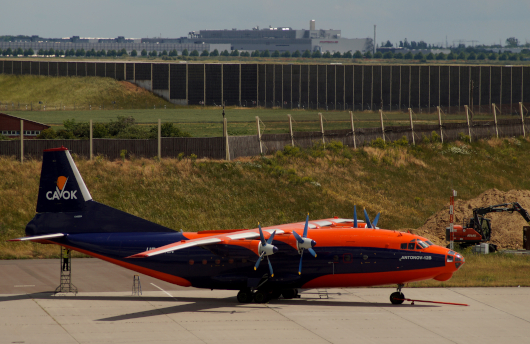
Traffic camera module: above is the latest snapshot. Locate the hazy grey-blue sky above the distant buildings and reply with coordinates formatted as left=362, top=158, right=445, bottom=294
left=0, top=0, right=530, bottom=46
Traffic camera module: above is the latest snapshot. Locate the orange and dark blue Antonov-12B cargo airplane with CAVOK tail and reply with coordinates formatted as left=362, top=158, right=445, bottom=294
left=8, top=147, right=464, bottom=304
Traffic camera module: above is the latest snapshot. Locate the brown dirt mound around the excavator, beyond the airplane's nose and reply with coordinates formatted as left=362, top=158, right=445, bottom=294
left=414, top=189, right=530, bottom=249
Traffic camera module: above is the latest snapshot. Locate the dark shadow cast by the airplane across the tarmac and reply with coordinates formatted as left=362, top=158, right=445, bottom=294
left=0, top=293, right=434, bottom=321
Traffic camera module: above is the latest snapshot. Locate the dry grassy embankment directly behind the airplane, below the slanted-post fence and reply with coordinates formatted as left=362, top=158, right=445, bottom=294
left=0, top=139, right=530, bottom=286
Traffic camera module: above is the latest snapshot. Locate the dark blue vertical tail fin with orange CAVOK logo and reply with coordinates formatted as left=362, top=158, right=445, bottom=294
left=37, top=147, right=92, bottom=213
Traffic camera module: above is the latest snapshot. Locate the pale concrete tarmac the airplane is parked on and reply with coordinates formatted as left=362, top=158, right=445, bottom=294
left=0, top=259, right=530, bottom=344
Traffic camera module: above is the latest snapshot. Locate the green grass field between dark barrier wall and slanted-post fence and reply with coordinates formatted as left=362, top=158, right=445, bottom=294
left=0, top=75, right=513, bottom=137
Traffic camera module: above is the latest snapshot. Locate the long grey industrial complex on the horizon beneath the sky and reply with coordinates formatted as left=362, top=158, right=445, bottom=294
left=0, top=20, right=373, bottom=55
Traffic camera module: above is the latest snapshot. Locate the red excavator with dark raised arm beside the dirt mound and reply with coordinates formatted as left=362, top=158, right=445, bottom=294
left=445, top=202, right=530, bottom=252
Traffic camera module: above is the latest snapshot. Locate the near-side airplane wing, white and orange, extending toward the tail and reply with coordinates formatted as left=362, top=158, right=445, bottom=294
left=127, top=228, right=284, bottom=258
